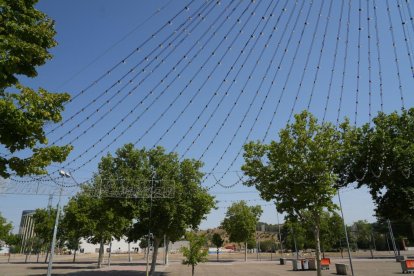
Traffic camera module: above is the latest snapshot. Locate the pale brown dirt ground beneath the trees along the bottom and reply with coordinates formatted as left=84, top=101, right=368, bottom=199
left=0, top=252, right=410, bottom=276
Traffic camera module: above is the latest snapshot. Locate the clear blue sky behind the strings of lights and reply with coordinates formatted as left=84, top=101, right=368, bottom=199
left=0, top=0, right=414, bottom=230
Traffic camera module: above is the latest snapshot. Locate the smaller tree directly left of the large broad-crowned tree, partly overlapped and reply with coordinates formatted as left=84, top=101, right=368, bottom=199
left=64, top=188, right=131, bottom=267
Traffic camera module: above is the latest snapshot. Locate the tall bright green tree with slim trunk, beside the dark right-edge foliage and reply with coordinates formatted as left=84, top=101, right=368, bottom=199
left=242, top=111, right=347, bottom=275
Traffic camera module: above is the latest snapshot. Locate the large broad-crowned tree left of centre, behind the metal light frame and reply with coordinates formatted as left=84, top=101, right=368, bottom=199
left=99, top=144, right=215, bottom=274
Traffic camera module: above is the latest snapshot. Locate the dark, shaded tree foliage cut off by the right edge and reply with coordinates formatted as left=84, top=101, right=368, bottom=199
left=346, top=108, right=414, bottom=221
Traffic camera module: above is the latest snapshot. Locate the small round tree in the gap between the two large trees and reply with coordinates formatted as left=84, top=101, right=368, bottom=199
left=221, top=200, right=262, bottom=261
